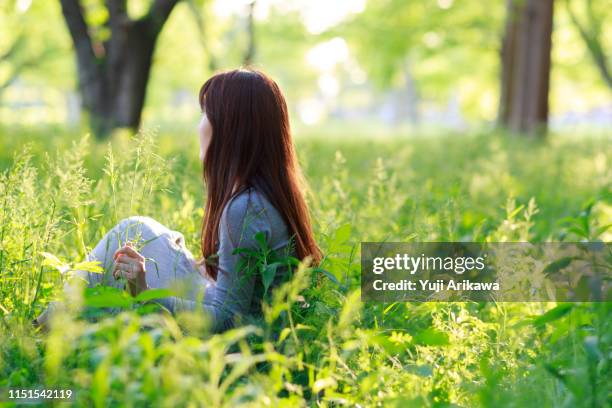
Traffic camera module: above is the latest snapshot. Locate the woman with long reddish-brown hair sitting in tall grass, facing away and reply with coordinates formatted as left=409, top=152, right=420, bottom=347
left=37, top=69, right=321, bottom=332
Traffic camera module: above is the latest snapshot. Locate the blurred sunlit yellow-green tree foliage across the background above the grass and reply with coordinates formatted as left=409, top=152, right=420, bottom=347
left=0, top=0, right=612, bottom=126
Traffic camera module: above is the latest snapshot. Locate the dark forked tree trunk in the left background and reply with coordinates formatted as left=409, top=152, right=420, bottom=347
left=61, top=0, right=178, bottom=138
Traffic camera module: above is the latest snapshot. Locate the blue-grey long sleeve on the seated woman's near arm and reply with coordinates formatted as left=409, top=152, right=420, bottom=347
left=155, top=190, right=272, bottom=332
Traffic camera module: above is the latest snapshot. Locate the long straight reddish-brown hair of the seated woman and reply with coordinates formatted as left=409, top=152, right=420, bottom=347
left=200, top=69, right=322, bottom=280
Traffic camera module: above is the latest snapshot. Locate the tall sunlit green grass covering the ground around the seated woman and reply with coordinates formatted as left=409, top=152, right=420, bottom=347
left=0, top=129, right=612, bottom=407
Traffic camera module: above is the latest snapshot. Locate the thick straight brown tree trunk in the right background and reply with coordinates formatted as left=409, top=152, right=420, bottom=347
left=498, top=0, right=554, bottom=134
